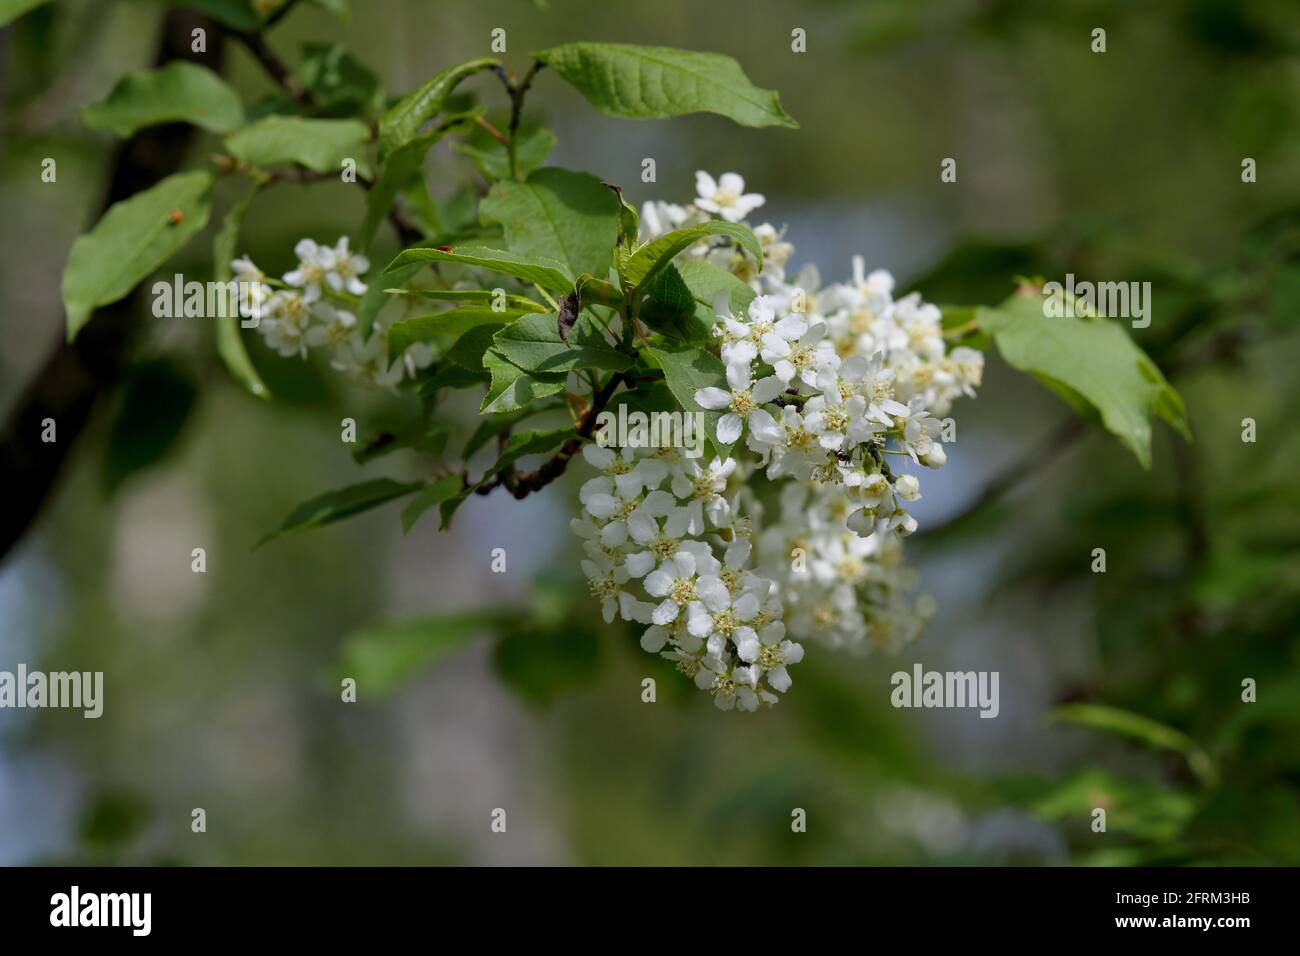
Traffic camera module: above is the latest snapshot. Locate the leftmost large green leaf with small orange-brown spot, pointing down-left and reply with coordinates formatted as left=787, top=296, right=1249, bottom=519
left=62, top=173, right=212, bottom=341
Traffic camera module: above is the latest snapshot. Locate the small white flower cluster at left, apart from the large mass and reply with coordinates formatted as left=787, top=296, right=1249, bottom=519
left=230, top=235, right=433, bottom=388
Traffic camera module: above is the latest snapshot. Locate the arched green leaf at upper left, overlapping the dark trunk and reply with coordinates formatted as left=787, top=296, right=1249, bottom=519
left=81, top=60, right=243, bottom=137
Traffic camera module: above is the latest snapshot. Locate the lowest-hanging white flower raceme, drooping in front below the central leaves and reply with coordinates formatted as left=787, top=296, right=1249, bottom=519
left=573, top=445, right=803, bottom=710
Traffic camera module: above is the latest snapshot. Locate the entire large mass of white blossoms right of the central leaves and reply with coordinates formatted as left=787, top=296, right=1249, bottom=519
left=575, top=172, right=983, bottom=709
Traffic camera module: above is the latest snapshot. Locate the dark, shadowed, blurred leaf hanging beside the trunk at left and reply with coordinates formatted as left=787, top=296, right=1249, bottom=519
left=104, top=359, right=199, bottom=493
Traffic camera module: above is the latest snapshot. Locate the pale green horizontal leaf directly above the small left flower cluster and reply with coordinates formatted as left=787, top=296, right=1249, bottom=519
left=226, top=116, right=371, bottom=176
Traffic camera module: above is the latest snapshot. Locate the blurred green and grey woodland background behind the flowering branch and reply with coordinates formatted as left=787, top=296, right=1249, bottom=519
left=0, top=0, right=1300, bottom=865
